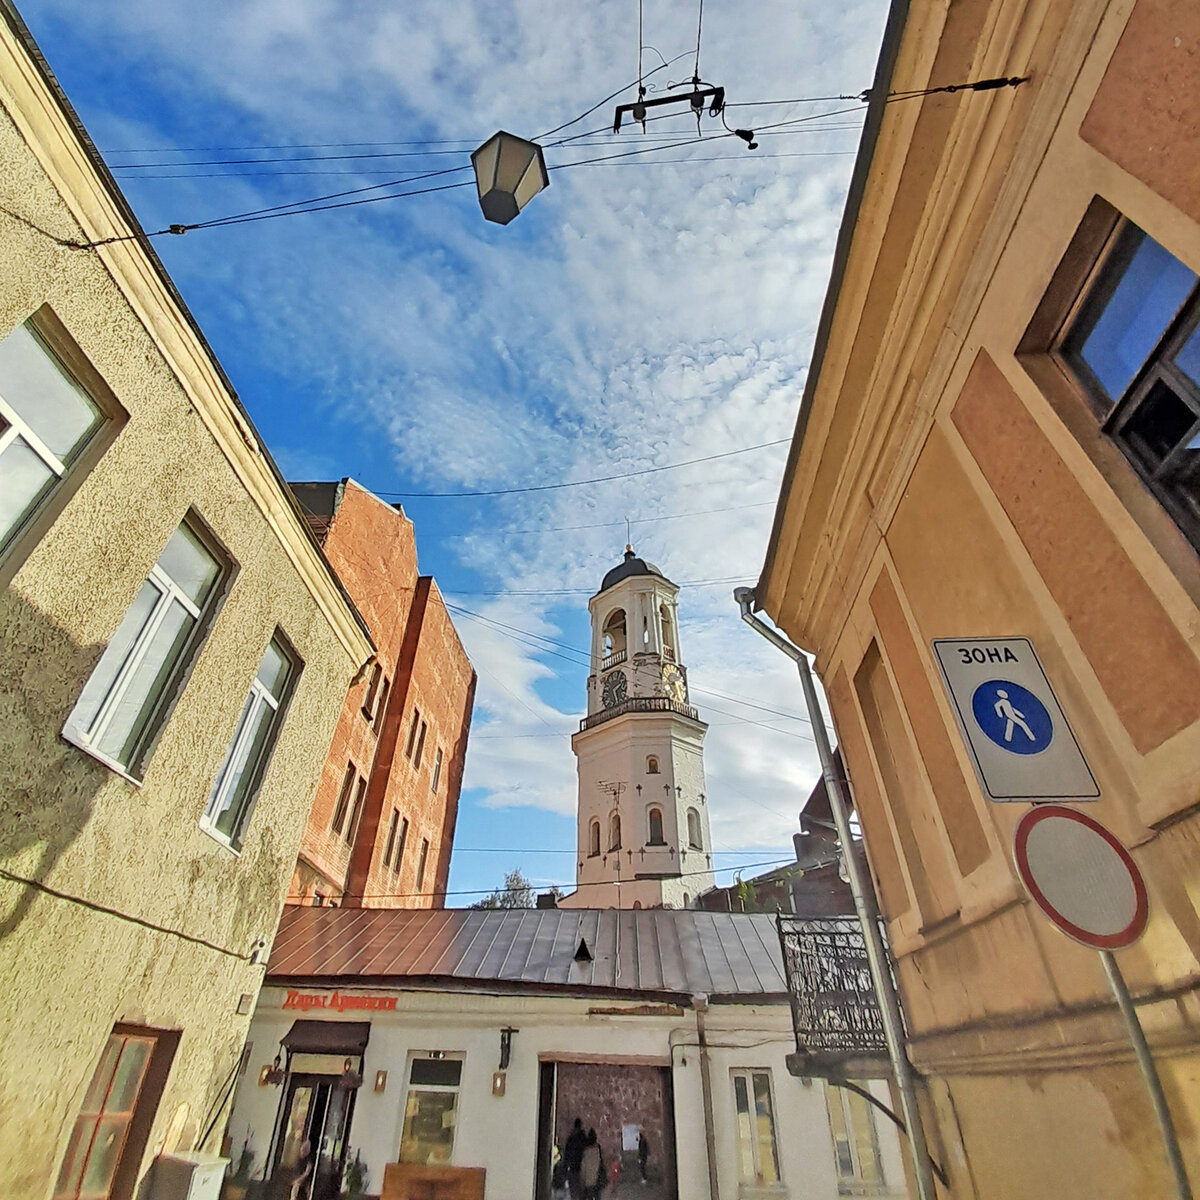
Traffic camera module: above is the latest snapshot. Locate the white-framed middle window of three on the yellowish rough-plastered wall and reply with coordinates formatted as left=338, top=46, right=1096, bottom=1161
left=62, top=521, right=222, bottom=774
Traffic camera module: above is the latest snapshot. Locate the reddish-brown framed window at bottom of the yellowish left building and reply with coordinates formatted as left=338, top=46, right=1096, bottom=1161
left=54, top=1025, right=178, bottom=1200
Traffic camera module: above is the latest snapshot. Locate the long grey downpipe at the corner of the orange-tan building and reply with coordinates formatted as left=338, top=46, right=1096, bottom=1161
left=734, top=588, right=937, bottom=1200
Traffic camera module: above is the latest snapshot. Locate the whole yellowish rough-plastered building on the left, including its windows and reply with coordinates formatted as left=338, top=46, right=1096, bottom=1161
left=0, top=5, right=373, bottom=1200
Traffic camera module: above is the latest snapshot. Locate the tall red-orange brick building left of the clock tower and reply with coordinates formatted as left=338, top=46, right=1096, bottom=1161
left=288, top=479, right=475, bottom=907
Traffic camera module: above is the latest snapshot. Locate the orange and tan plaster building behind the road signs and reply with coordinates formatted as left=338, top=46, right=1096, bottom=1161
left=756, top=0, right=1200, bottom=1200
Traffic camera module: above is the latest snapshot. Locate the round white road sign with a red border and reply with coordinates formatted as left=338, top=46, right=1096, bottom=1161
left=1013, top=804, right=1148, bottom=950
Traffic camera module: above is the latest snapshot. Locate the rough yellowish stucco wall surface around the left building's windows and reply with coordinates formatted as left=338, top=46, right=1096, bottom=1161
left=0, top=11, right=370, bottom=1200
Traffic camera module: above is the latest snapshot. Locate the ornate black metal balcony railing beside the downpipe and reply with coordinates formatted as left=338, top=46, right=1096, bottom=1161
left=778, top=914, right=888, bottom=1075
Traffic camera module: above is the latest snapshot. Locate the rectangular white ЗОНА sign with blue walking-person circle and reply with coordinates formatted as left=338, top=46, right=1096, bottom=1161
left=934, top=637, right=1100, bottom=802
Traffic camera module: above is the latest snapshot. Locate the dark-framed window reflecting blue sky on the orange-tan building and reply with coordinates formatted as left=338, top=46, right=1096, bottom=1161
left=1052, top=213, right=1200, bottom=547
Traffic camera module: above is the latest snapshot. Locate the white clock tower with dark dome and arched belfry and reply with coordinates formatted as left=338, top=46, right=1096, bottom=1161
left=559, top=546, right=713, bottom=908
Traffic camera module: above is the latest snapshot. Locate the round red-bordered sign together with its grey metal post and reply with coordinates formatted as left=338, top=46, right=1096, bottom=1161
left=1013, top=804, right=1192, bottom=1200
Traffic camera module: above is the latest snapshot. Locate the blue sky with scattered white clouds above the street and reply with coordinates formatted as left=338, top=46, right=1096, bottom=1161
left=20, top=0, right=886, bottom=904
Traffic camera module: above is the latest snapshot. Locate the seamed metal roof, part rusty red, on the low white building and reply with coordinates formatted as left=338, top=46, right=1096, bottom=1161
left=266, top=906, right=787, bottom=1003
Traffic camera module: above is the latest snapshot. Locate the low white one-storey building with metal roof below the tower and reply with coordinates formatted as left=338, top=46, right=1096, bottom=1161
left=229, top=907, right=906, bottom=1200
